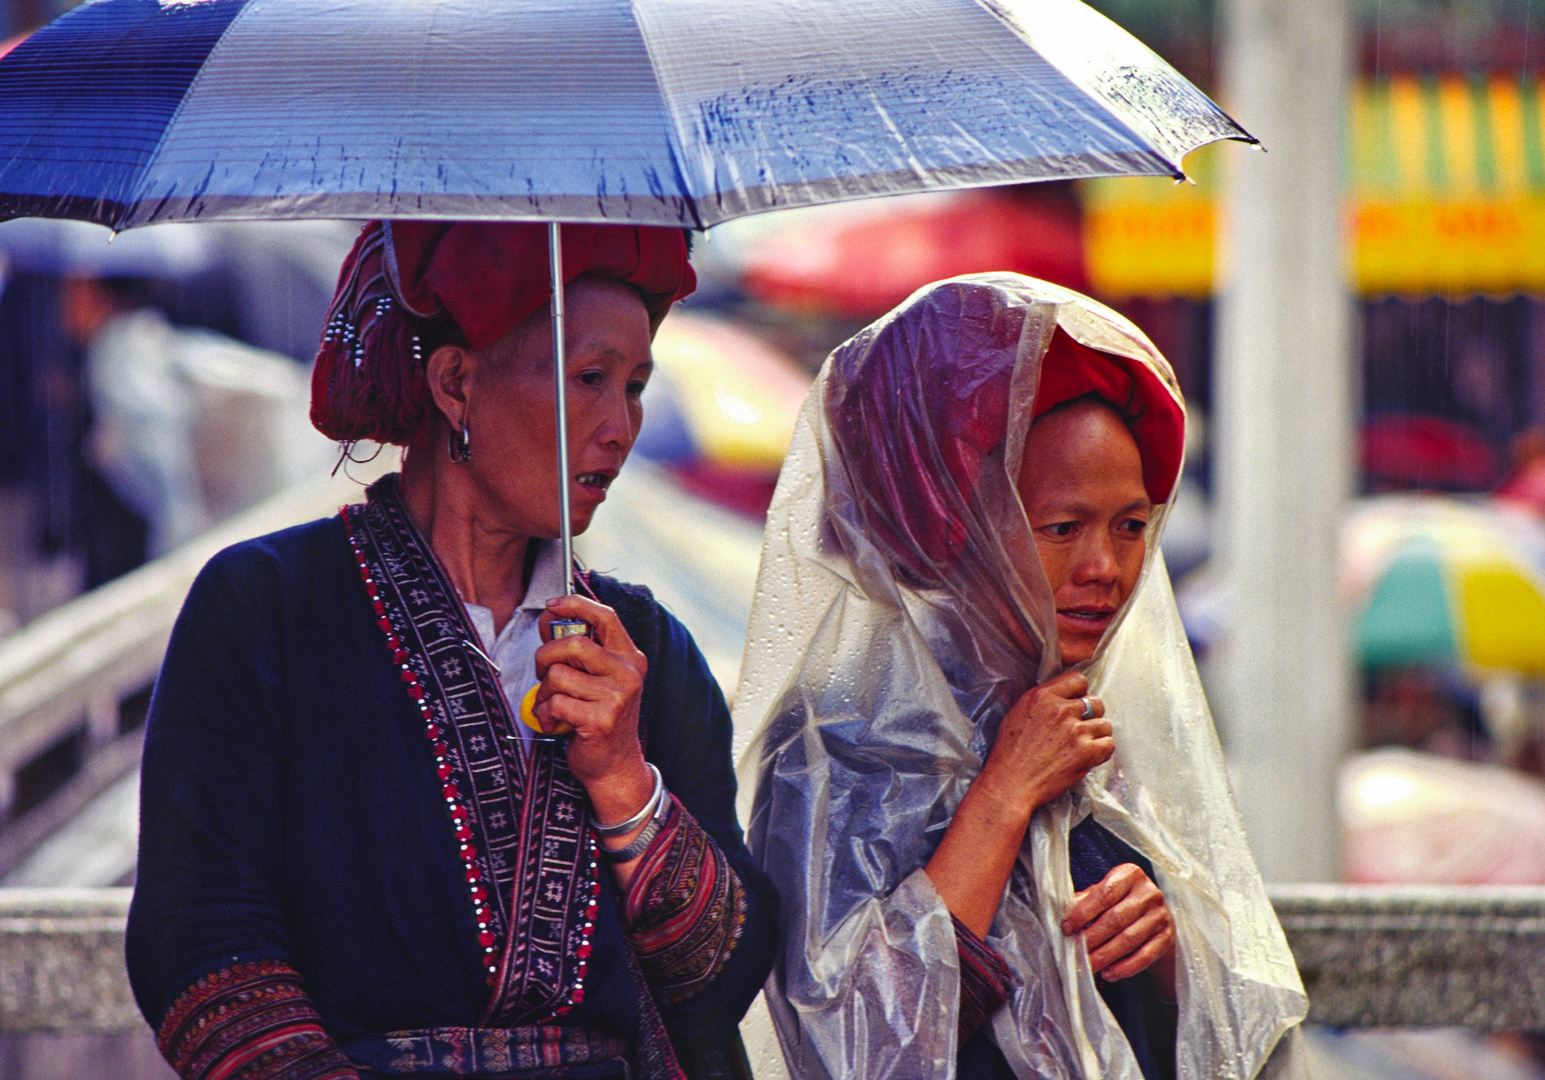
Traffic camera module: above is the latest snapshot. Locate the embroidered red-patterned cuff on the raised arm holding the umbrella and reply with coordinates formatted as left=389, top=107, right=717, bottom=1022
left=623, top=796, right=746, bottom=1004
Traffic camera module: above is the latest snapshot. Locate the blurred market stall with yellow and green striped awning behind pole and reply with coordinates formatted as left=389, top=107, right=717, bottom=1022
left=1080, top=68, right=1545, bottom=506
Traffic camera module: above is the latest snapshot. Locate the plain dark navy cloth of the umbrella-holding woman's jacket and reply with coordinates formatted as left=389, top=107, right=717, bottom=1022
left=128, top=518, right=776, bottom=1071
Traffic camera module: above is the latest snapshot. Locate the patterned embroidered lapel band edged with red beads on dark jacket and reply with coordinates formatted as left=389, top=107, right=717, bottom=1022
left=341, top=476, right=601, bottom=1026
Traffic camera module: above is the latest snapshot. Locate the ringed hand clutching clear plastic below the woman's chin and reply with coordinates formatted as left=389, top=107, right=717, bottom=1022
left=976, top=672, right=1115, bottom=819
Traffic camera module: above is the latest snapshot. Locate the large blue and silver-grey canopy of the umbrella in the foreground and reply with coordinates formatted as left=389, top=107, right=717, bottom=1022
left=0, top=0, right=1248, bottom=229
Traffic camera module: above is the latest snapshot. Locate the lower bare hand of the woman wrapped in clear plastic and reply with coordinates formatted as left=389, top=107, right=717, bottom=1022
left=1061, top=862, right=1176, bottom=1001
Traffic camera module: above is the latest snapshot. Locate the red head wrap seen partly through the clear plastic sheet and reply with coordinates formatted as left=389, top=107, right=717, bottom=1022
left=827, top=278, right=1185, bottom=581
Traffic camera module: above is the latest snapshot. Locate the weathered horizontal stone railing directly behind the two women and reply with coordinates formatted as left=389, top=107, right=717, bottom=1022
left=0, top=885, right=1545, bottom=1034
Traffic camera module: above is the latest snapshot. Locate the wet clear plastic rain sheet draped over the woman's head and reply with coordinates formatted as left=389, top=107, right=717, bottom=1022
left=735, top=275, right=1306, bottom=1080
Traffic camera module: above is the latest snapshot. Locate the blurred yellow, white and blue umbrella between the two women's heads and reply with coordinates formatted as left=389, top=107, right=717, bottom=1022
left=633, top=312, right=811, bottom=516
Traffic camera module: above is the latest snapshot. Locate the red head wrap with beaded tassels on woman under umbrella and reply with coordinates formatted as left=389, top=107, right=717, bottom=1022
left=311, top=221, right=697, bottom=445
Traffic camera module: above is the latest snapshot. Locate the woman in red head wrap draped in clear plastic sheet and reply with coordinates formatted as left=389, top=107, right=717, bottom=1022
left=735, top=273, right=1306, bottom=1080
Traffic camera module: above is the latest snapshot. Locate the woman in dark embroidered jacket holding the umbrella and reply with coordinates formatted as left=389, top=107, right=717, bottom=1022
left=128, top=222, right=774, bottom=1080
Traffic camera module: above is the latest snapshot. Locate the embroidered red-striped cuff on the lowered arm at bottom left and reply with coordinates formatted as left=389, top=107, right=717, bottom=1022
left=156, top=959, right=358, bottom=1080
